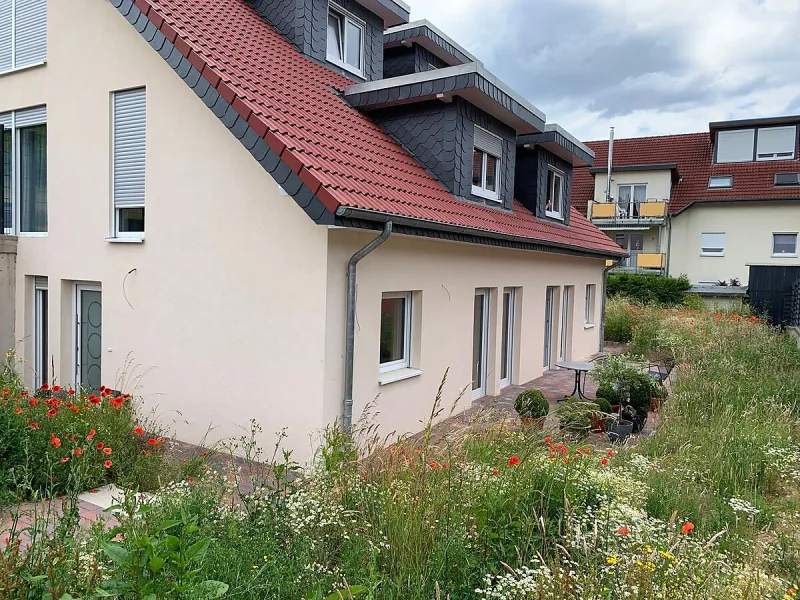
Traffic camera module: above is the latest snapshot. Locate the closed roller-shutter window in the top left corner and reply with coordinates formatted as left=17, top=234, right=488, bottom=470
left=0, top=0, right=47, bottom=73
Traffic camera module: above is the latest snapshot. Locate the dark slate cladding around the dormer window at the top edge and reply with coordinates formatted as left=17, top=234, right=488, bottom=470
left=247, top=0, right=383, bottom=81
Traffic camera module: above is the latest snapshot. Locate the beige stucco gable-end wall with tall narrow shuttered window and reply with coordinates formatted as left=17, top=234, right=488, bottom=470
left=0, top=0, right=327, bottom=456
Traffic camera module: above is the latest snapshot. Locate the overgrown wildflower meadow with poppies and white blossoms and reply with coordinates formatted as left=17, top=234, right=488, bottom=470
left=0, top=299, right=800, bottom=600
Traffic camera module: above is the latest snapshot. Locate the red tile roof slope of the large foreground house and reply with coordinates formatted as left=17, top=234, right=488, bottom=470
left=125, top=0, right=620, bottom=254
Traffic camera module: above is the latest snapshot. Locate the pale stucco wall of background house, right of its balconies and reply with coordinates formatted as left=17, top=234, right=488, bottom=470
left=669, top=202, right=800, bottom=285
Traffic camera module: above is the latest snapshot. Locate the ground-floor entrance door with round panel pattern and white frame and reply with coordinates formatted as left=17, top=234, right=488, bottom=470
left=75, top=285, right=103, bottom=388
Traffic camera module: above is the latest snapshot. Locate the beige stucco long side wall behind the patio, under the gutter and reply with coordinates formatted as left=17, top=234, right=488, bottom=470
left=325, top=229, right=604, bottom=434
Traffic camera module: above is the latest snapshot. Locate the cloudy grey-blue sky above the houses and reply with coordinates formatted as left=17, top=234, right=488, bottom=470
left=407, top=0, right=800, bottom=140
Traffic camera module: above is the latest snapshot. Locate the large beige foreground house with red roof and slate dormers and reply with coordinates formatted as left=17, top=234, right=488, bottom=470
left=0, top=0, right=623, bottom=456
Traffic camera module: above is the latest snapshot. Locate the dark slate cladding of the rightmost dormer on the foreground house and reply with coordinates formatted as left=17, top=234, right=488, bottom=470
left=514, top=146, right=572, bottom=225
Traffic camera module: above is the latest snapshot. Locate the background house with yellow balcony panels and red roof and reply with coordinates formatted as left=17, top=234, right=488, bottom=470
left=573, top=116, right=800, bottom=286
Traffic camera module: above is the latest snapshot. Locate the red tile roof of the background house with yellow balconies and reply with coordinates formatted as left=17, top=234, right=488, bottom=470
left=572, top=133, right=800, bottom=214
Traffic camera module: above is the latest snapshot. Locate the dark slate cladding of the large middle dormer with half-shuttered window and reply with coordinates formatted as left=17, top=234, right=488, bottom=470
left=370, top=97, right=516, bottom=210
